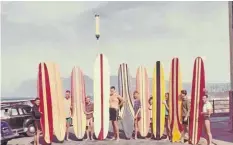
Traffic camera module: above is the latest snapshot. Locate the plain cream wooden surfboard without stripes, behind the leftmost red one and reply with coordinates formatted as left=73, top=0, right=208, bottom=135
left=47, top=63, right=66, bottom=141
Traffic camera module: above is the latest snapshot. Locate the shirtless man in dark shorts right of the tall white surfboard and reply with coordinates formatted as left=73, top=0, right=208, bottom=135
left=109, top=86, right=124, bottom=141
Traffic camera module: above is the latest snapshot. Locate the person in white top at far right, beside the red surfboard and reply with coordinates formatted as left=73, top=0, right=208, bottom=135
left=201, top=94, right=213, bottom=145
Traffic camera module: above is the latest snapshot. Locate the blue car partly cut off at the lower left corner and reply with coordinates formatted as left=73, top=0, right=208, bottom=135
left=1, top=121, right=17, bottom=145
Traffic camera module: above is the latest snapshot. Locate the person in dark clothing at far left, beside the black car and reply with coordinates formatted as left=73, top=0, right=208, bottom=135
left=32, top=98, right=42, bottom=145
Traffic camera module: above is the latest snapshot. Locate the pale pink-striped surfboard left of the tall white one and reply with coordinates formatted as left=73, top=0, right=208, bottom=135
left=71, top=67, right=86, bottom=139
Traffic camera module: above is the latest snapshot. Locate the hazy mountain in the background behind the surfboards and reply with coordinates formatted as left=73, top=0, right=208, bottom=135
left=2, top=75, right=230, bottom=98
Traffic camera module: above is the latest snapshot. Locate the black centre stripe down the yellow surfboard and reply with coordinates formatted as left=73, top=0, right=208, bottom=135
left=156, top=61, right=161, bottom=138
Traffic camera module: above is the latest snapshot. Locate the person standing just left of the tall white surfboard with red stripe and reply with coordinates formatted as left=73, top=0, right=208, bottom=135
left=85, top=96, right=94, bottom=140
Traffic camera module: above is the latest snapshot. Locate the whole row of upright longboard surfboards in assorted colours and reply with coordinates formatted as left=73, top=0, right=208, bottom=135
left=37, top=54, right=205, bottom=144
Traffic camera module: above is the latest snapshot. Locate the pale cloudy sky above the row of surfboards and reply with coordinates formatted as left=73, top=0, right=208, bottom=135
left=1, top=1, right=230, bottom=91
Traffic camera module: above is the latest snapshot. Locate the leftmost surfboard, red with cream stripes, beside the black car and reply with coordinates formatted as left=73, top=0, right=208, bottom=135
left=37, top=62, right=53, bottom=144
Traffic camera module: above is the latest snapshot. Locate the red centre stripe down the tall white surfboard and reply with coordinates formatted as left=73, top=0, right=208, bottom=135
left=98, top=54, right=104, bottom=140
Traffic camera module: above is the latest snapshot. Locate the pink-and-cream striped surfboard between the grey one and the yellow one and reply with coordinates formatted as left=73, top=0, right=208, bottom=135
left=136, top=66, right=150, bottom=137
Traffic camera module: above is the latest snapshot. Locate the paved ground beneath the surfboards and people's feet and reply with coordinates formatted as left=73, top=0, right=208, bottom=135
left=8, top=117, right=233, bottom=145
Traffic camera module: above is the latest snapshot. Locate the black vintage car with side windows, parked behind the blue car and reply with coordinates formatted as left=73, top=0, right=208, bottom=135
left=1, top=104, right=35, bottom=136
